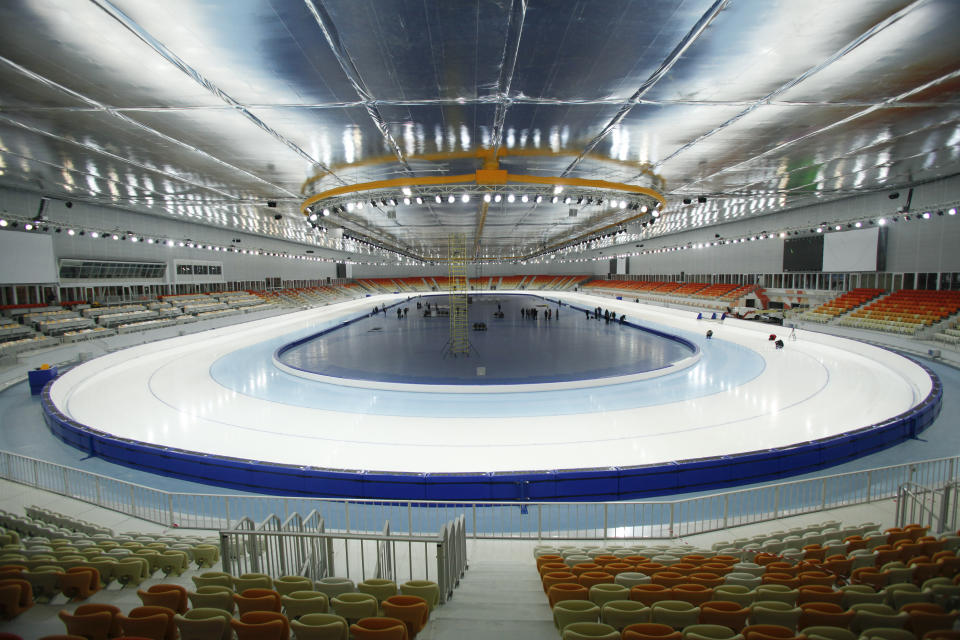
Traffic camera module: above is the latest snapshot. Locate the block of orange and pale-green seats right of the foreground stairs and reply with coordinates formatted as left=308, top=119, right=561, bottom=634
left=534, top=522, right=960, bottom=640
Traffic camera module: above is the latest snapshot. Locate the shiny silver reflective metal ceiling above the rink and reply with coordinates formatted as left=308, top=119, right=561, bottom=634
left=0, top=0, right=960, bottom=259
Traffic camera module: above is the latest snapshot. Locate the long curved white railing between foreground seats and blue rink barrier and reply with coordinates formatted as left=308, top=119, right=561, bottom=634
left=0, top=452, right=960, bottom=540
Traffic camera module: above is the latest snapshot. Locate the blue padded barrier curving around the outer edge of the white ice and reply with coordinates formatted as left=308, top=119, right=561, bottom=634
left=35, top=352, right=943, bottom=503
